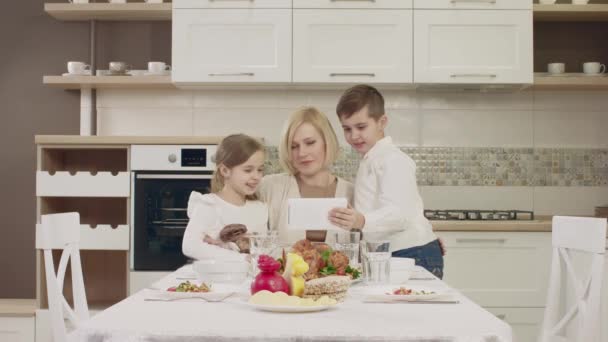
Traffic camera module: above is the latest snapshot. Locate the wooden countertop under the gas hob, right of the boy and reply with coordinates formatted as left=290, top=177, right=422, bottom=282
left=430, top=216, right=551, bottom=232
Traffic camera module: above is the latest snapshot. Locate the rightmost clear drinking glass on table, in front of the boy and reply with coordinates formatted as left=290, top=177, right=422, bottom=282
left=361, top=240, right=391, bottom=285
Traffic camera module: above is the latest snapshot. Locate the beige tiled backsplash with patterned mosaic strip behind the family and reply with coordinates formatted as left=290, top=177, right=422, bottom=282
left=97, top=88, right=608, bottom=215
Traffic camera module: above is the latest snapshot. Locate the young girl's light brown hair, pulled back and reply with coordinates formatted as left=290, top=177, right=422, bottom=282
left=211, top=134, right=264, bottom=200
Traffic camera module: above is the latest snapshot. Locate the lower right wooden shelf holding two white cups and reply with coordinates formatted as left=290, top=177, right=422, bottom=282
left=534, top=73, right=608, bottom=90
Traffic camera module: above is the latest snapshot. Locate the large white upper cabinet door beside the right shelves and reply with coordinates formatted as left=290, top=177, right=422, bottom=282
left=414, top=10, right=533, bottom=84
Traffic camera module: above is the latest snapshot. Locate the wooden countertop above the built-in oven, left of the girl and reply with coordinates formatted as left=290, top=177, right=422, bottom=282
left=34, top=135, right=223, bottom=145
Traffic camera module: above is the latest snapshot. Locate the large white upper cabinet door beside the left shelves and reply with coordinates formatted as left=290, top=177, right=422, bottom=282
left=172, top=9, right=291, bottom=84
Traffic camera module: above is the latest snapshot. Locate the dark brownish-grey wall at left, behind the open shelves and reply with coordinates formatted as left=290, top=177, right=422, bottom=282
left=0, top=0, right=171, bottom=298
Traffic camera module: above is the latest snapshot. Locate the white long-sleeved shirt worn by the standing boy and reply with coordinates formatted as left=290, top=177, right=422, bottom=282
left=355, top=137, right=437, bottom=251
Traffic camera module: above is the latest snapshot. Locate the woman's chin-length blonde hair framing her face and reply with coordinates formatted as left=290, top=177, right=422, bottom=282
left=279, top=107, right=339, bottom=175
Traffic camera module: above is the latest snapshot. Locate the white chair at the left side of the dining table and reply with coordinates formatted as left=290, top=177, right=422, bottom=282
left=36, top=213, right=89, bottom=342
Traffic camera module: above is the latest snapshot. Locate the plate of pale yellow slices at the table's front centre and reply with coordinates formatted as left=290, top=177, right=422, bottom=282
left=247, top=290, right=338, bottom=313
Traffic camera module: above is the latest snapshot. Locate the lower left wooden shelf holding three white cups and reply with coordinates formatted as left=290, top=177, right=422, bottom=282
left=42, top=76, right=175, bottom=89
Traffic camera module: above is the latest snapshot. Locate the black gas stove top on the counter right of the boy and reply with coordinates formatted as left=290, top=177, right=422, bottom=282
left=424, top=209, right=534, bottom=221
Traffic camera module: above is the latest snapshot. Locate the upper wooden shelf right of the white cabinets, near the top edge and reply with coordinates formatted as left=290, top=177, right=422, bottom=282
left=534, top=4, right=608, bottom=21
